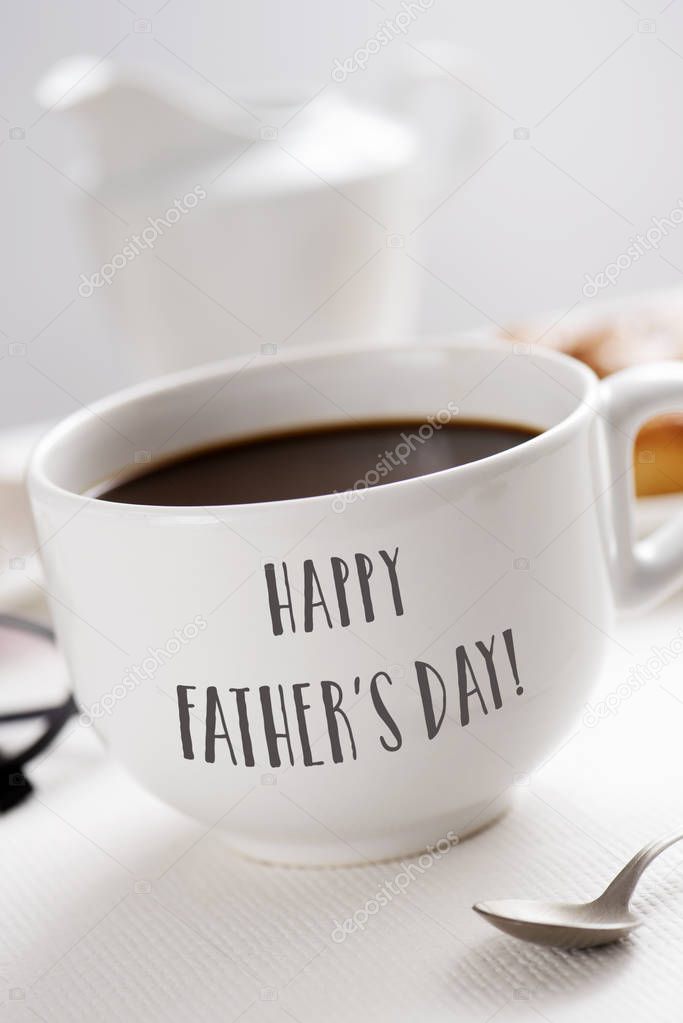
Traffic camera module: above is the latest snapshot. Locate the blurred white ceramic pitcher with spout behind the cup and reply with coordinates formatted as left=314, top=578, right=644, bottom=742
left=39, top=49, right=484, bottom=377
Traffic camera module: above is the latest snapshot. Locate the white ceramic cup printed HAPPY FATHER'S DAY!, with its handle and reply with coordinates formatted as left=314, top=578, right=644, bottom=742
left=30, top=342, right=683, bottom=863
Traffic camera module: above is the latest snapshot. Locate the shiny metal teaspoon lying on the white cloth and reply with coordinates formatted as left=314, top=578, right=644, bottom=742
left=472, top=832, right=683, bottom=948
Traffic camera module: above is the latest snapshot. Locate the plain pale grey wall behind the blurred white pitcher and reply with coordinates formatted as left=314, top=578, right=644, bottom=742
left=0, top=0, right=683, bottom=425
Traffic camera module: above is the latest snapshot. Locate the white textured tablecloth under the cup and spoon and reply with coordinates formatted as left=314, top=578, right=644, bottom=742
left=0, top=581, right=683, bottom=1023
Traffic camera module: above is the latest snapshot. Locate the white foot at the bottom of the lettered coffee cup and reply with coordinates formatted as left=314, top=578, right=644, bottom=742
left=221, top=794, right=513, bottom=868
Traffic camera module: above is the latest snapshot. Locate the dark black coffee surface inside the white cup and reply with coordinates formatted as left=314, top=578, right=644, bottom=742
left=97, top=421, right=537, bottom=506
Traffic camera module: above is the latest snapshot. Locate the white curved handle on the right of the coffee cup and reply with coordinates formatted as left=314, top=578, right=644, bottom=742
left=598, top=362, right=683, bottom=613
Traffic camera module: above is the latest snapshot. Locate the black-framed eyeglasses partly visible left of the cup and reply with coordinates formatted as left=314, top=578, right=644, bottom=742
left=0, top=615, right=78, bottom=813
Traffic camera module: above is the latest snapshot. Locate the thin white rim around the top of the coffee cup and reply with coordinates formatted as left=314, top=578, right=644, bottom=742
left=27, top=336, right=599, bottom=523
